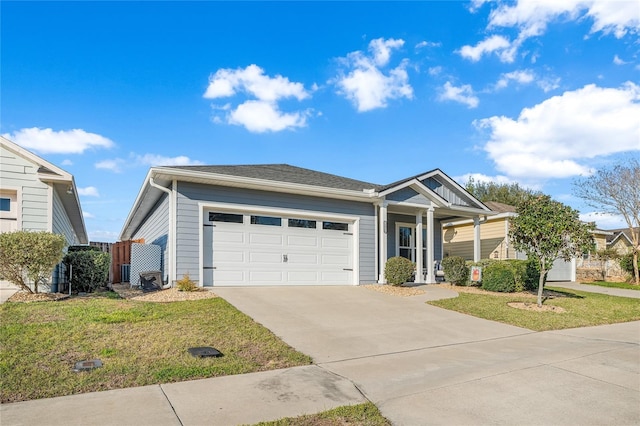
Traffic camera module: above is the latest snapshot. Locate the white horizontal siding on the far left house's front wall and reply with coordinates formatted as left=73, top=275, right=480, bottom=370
left=0, top=147, right=49, bottom=231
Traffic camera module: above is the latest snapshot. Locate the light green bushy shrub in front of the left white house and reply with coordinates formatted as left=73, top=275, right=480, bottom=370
left=0, top=231, right=65, bottom=293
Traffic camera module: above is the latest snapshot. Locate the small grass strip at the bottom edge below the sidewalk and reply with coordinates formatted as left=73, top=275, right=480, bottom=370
left=250, top=402, right=391, bottom=426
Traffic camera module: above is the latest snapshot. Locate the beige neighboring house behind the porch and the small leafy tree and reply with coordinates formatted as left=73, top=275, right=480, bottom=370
left=442, top=201, right=523, bottom=260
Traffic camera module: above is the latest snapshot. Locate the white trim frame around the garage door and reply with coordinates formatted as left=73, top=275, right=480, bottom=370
left=198, top=201, right=360, bottom=286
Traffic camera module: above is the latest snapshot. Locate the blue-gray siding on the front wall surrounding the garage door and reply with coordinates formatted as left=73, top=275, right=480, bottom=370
left=176, top=182, right=376, bottom=283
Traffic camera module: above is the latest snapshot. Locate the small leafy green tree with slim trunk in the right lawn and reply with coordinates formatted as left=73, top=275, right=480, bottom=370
left=509, top=195, right=595, bottom=306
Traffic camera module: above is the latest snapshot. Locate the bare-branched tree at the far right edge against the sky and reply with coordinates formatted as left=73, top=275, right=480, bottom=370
left=574, top=158, right=640, bottom=285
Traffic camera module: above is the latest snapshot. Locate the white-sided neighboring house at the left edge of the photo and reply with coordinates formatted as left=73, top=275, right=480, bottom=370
left=0, top=136, right=88, bottom=290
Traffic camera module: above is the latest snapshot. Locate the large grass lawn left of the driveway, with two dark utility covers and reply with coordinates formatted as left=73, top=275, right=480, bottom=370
left=0, top=296, right=311, bottom=403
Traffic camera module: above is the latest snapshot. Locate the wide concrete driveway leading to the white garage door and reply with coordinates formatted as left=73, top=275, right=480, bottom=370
left=216, top=286, right=640, bottom=425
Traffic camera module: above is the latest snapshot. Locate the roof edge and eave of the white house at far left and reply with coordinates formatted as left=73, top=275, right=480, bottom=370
left=0, top=136, right=89, bottom=244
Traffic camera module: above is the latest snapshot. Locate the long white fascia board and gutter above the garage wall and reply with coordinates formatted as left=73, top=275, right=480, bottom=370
left=156, top=168, right=377, bottom=201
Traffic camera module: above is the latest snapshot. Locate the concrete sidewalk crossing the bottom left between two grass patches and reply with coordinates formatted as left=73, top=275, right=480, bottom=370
left=0, top=365, right=366, bottom=426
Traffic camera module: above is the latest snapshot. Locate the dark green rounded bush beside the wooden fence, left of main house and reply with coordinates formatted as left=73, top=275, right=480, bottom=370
left=64, top=250, right=111, bottom=293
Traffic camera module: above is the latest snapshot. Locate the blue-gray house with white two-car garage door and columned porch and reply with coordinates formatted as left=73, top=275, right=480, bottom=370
left=120, top=164, right=494, bottom=287
